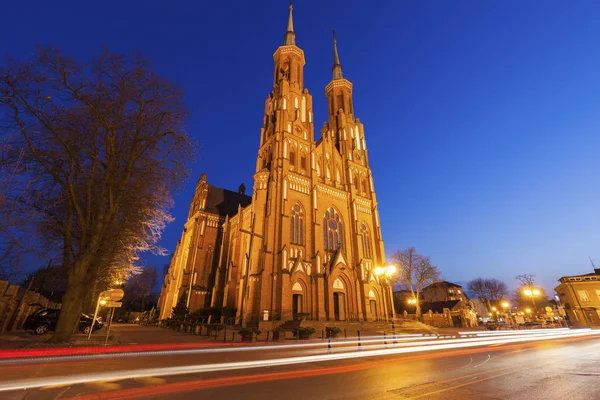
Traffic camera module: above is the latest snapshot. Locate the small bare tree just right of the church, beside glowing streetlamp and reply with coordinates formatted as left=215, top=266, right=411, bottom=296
left=392, top=247, right=440, bottom=319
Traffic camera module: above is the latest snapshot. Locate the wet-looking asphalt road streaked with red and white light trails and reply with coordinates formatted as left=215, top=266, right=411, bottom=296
left=0, top=328, right=600, bottom=400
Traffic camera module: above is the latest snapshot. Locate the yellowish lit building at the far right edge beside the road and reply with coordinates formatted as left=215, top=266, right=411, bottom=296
left=554, top=268, right=600, bottom=326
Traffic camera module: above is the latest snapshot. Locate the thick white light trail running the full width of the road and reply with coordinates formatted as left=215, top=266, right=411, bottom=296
left=0, top=329, right=600, bottom=391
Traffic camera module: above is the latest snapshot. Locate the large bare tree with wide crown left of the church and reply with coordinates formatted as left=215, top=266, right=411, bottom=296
left=0, top=49, right=194, bottom=340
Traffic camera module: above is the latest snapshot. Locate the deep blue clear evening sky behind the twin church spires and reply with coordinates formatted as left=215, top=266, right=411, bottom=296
left=0, top=0, right=600, bottom=289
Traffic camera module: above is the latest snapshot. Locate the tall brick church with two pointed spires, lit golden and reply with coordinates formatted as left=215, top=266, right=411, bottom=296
left=159, top=6, right=394, bottom=325
